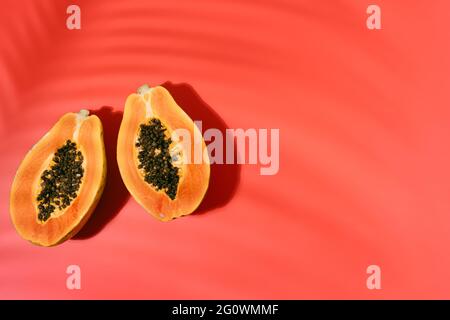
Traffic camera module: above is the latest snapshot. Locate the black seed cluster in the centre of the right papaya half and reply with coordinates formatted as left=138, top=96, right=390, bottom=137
left=136, top=118, right=180, bottom=200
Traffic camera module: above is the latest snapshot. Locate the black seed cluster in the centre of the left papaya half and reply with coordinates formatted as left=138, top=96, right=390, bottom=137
left=37, top=140, right=84, bottom=221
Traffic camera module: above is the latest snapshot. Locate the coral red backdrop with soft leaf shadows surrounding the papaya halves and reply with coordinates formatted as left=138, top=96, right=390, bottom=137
left=0, top=0, right=450, bottom=299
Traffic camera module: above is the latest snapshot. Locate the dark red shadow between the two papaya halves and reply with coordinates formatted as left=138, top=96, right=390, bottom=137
left=73, top=106, right=130, bottom=240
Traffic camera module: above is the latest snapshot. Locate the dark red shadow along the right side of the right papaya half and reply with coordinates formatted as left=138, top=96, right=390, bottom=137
left=162, top=82, right=241, bottom=214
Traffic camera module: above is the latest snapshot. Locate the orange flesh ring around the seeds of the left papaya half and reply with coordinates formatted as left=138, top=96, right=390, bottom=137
left=10, top=112, right=106, bottom=247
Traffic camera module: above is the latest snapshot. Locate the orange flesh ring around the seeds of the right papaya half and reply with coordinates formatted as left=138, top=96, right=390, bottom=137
left=117, top=86, right=210, bottom=221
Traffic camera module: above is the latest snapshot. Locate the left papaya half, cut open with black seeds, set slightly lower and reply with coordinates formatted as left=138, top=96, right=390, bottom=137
left=10, top=110, right=106, bottom=246
